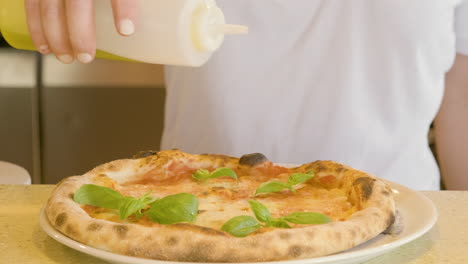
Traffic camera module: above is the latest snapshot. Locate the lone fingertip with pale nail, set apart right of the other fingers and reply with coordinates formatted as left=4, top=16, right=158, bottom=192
left=112, top=0, right=139, bottom=36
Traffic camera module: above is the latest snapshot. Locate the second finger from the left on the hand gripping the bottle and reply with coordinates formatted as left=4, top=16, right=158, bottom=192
left=40, top=0, right=74, bottom=64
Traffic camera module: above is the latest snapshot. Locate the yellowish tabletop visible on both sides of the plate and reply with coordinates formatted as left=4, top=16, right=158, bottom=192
left=0, top=185, right=468, bottom=264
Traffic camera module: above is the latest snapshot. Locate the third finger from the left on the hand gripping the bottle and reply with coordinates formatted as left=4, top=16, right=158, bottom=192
left=65, top=0, right=95, bottom=63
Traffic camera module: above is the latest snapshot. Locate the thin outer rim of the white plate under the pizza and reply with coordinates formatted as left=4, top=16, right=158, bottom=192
left=39, top=182, right=438, bottom=264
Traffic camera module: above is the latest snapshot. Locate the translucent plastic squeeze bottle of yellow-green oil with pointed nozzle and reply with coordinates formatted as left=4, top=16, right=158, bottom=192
left=0, top=0, right=248, bottom=67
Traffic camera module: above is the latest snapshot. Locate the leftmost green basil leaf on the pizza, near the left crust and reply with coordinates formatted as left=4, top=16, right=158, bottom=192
left=73, top=184, right=124, bottom=209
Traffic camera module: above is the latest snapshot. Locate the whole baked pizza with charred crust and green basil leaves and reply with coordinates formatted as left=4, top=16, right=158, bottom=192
left=45, top=150, right=396, bottom=262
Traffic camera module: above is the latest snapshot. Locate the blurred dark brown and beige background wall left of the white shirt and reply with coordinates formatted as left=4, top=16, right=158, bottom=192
left=0, top=37, right=165, bottom=183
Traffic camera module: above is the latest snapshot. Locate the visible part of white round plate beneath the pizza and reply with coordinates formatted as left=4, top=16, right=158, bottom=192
left=39, top=182, right=437, bottom=264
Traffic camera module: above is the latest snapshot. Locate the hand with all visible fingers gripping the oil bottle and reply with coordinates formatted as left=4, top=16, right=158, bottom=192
left=24, top=0, right=138, bottom=64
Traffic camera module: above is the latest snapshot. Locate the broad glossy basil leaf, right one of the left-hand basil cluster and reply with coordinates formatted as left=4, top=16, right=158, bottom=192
left=145, top=193, right=198, bottom=225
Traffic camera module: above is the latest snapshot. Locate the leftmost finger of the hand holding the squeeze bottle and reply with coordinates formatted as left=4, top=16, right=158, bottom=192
left=24, top=0, right=50, bottom=55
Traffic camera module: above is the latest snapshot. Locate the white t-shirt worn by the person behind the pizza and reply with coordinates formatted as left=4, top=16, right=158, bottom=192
left=162, top=0, right=468, bottom=190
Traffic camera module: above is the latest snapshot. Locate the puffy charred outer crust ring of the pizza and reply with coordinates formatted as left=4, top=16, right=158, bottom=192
left=45, top=150, right=395, bottom=262
